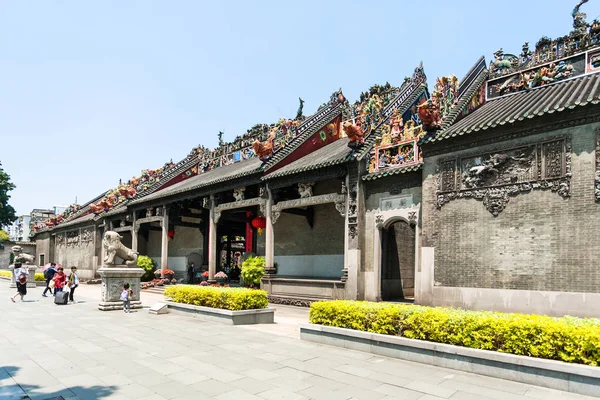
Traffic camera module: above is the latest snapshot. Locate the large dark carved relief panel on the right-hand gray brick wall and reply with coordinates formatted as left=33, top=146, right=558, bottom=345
left=437, top=135, right=571, bottom=216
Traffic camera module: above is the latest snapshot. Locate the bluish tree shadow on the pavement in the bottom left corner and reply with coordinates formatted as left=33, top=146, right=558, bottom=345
left=0, top=366, right=117, bottom=400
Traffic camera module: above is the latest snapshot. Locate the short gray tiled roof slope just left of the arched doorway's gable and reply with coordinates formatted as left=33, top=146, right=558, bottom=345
left=263, top=138, right=352, bottom=180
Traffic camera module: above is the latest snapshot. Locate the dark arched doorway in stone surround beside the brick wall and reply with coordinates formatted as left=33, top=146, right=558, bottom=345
left=381, top=221, right=415, bottom=301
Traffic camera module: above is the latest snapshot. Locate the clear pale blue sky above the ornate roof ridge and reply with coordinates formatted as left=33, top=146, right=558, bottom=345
left=0, top=0, right=600, bottom=214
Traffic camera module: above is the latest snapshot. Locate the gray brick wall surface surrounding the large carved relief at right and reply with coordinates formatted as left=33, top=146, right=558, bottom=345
left=422, top=124, right=600, bottom=293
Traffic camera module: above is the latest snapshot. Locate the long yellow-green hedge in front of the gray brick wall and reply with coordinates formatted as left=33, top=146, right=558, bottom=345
left=310, top=300, right=600, bottom=366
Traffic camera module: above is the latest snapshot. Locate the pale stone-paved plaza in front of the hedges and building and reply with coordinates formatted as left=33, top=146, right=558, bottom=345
left=0, top=281, right=591, bottom=400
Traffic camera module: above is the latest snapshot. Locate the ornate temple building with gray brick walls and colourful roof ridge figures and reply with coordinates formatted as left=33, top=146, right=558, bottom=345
left=31, top=8, right=600, bottom=316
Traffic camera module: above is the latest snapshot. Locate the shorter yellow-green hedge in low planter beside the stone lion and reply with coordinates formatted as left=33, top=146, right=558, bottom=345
left=165, top=285, right=268, bottom=311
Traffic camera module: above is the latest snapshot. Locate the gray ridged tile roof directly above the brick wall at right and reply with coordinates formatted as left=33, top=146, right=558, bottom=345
left=429, top=74, right=600, bottom=142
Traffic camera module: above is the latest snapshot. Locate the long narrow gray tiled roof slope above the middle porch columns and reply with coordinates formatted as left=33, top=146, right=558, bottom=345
left=129, top=158, right=262, bottom=204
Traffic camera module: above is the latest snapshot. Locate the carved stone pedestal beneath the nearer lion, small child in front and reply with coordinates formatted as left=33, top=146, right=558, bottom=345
left=98, top=265, right=145, bottom=311
